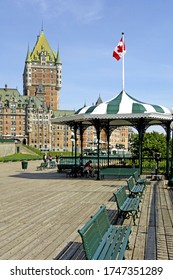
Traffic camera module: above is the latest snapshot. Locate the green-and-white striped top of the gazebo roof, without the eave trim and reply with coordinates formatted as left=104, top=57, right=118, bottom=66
left=75, top=91, right=171, bottom=115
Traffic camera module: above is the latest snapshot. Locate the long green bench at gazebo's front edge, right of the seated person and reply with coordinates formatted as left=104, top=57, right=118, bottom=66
left=100, top=167, right=138, bottom=179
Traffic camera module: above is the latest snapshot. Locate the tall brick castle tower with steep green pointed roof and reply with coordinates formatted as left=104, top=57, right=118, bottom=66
left=23, top=30, right=62, bottom=110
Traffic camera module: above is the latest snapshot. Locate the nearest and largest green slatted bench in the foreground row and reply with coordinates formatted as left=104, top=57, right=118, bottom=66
left=78, top=205, right=131, bottom=260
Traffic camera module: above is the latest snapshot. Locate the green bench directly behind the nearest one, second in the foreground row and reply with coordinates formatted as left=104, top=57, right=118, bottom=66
left=114, top=186, right=140, bottom=226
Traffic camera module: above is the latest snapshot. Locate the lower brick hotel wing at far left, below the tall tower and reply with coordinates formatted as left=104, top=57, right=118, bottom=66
left=0, top=85, right=52, bottom=148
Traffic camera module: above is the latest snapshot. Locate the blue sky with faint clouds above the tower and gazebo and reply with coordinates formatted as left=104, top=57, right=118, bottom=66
left=0, top=0, right=173, bottom=124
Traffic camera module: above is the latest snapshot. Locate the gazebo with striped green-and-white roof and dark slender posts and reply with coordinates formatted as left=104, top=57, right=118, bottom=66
left=52, top=90, right=172, bottom=179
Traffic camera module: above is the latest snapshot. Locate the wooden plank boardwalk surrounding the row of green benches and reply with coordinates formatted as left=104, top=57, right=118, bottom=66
left=0, top=161, right=173, bottom=260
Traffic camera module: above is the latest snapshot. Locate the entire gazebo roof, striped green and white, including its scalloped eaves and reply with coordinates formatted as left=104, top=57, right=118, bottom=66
left=52, top=91, right=172, bottom=127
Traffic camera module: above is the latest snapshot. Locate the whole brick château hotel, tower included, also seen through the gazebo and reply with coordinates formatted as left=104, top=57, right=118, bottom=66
left=0, top=30, right=128, bottom=152
